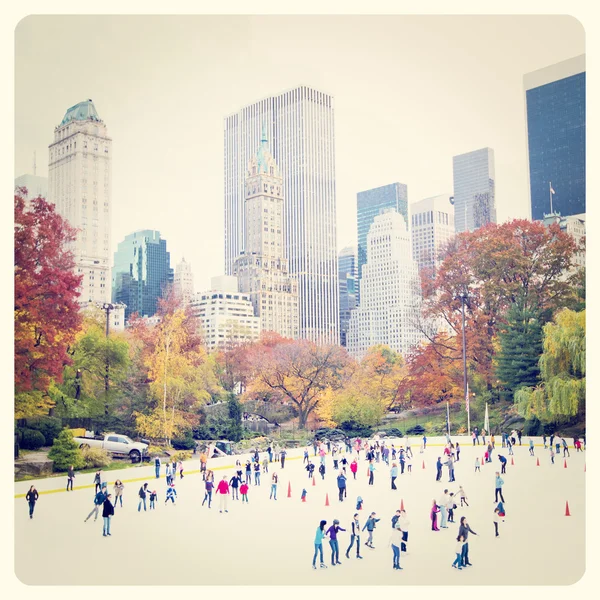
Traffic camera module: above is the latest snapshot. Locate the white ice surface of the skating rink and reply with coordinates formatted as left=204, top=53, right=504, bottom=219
left=15, top=438, right=585, bottom=585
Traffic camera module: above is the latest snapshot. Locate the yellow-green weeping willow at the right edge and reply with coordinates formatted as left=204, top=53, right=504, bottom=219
left=515, top=309, right=585, bottom=422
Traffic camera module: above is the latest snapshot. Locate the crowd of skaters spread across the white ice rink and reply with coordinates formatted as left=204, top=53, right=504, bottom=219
left=26, top=428, right=585, bottom=570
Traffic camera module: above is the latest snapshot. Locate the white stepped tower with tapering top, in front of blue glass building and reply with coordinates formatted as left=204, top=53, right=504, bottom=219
left=348, top=209, right=422, bottom=359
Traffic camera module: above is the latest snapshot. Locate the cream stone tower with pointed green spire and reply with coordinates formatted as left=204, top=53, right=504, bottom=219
left=233, top=130, right=299, bottom=339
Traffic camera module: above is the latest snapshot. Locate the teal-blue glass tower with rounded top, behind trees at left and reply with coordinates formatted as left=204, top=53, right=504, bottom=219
left=112, top=229, right=173, bottom=319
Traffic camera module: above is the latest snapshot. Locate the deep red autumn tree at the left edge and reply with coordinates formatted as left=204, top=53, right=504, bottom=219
left=14, top=189, right=81, bottom=417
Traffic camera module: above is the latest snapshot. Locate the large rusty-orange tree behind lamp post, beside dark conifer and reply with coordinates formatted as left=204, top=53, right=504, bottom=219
left=421, top=219, right=578, bottom=386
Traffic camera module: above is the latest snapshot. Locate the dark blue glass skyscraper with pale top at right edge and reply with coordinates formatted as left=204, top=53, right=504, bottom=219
left=523, top=54, right=586, bottom=221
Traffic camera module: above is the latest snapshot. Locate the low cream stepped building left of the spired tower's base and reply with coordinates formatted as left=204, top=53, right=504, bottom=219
left=190, top=275, right=260, bottom=352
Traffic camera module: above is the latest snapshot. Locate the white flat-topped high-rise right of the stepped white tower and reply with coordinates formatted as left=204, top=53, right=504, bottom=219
left=410, top=194, right=455, bottom=270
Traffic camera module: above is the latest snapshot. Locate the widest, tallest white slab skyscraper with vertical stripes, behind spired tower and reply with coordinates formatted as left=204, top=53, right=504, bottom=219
left=224, top=86, right=339, bottom=344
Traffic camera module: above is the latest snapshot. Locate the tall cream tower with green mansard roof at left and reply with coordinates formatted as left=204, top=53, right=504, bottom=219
left=48, top=100, right=112, bottom=307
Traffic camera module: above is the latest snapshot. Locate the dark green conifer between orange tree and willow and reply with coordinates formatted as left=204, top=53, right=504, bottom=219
left=496, top=303, right=542, bottom=398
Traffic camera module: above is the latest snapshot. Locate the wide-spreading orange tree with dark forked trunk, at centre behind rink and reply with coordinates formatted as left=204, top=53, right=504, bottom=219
left=246, top=340, right=349, bottom=428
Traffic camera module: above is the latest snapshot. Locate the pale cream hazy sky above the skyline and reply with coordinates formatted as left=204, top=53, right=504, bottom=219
left=15, top=16, right=585, bottom=291
